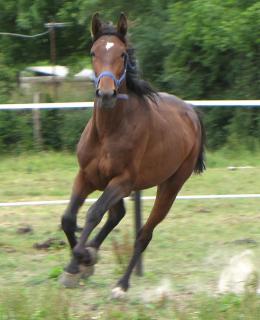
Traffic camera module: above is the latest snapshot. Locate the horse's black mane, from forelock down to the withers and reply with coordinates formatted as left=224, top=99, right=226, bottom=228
left=92, top=23, right=158, bottom=103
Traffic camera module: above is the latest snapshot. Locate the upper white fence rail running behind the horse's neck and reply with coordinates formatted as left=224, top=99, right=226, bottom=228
left=0, top=100, right=260, bottom=110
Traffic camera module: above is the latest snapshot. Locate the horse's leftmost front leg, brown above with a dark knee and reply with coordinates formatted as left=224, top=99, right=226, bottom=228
left=61, top=171, right=93, bottom=249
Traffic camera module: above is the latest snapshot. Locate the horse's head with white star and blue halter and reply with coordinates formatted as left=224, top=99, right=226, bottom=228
left=91, top=13, right=128, bottom=108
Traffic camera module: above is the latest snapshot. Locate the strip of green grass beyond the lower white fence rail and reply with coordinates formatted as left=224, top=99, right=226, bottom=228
left=0, top=152, right=260, bottom=201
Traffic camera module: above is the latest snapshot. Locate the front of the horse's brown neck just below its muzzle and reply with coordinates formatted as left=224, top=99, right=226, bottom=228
left=93, top=100, right=128, bottom=137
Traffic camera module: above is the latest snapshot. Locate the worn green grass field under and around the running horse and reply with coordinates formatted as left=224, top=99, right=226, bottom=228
left=0, top=153, right=260, bottom=320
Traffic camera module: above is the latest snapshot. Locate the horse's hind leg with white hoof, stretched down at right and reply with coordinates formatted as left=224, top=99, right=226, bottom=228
left=112, top=152, right=195, bottom=298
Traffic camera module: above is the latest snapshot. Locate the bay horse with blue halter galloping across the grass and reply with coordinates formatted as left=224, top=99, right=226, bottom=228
left=60, top=13, right=205, bottom=297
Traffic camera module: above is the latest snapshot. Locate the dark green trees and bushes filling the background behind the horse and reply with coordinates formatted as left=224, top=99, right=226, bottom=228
left=0, top=0, right=260, bottom=150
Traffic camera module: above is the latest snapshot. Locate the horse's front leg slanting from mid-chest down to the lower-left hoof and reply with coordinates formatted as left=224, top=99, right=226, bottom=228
left=62, top=175, right=132, bottom=286
